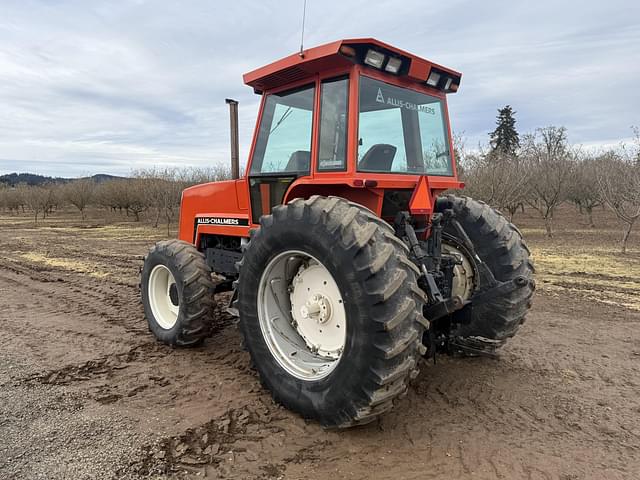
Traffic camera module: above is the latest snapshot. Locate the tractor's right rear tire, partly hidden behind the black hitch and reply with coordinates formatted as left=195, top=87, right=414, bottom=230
left=436, top=195, right=535, bottom=353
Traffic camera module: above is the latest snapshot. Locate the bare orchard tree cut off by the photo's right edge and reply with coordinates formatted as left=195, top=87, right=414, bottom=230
left=597, top=151, right=640, bottom=253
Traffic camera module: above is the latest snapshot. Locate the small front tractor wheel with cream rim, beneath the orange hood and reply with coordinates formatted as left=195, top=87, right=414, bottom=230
left=140, top=240, right=215, bottom=347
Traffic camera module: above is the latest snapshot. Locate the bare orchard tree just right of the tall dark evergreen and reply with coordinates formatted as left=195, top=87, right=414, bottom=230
left=523, top=126, right=575, bottom=237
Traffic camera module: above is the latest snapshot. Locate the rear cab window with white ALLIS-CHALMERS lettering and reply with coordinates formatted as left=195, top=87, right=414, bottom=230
left=358, top=76, right=453, bottom=176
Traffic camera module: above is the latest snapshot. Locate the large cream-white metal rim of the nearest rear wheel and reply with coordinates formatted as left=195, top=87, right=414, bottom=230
left=258, top=250, right=347, bottom=381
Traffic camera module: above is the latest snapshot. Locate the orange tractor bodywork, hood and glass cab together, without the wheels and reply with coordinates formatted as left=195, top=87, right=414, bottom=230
left=180, top=39, right=462, bottom=243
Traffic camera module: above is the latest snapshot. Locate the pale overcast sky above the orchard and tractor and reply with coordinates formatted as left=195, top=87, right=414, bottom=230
left=0, top=0, right=640, bottom=176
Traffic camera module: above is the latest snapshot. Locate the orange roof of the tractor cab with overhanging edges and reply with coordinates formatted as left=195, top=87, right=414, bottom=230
left=243, top=38, right=462, bottom=93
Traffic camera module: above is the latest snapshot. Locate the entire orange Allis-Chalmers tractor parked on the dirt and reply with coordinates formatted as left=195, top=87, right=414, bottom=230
left=141, top=38, right=535, bottom=427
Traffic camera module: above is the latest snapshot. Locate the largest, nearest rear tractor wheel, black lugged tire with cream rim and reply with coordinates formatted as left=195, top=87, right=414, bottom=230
left=238, top=196, right=428, bottom=427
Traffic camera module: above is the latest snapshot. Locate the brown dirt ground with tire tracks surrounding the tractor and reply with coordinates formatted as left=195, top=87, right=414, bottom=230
left=0, top=207, right=640, bottom=480
